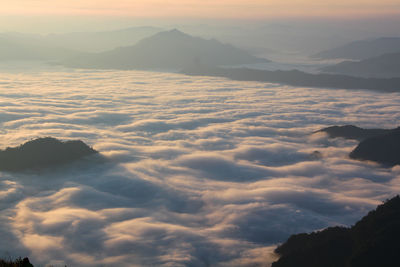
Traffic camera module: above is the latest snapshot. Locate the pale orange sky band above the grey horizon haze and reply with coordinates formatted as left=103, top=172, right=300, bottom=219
left=0, top=0, right=400, bottom=19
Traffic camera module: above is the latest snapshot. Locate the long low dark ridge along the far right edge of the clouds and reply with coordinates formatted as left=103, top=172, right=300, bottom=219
left=182, top=64, right=400, bottom=92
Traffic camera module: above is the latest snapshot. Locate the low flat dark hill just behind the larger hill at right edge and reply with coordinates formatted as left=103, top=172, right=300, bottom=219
left=316, top=125, right=399, bottom=141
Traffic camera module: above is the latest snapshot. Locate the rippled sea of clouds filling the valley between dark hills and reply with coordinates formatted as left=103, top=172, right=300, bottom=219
left=0, top=70, right=400, bottom=266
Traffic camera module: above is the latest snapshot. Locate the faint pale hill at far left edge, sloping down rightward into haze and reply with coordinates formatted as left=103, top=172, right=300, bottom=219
left=0, top=37, right=79, bottom=61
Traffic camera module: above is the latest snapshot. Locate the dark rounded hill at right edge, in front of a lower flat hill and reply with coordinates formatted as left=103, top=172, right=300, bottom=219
left=350, top=128, right=400, bottom=166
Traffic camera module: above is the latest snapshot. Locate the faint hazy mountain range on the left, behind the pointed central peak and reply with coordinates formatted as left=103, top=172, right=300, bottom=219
left=0, top=27, right=162, bottom=62
